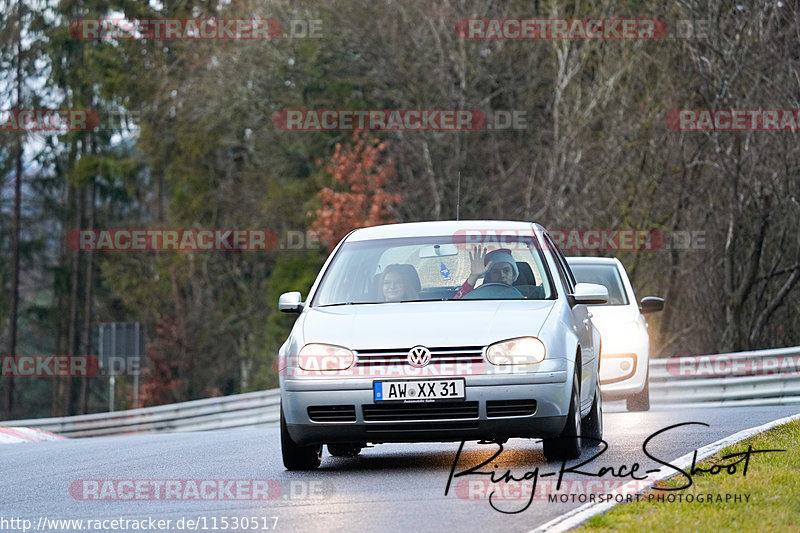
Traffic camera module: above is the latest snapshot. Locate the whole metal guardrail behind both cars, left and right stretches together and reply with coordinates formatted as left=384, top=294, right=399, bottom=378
left=0, top=346, right=800, bottom=437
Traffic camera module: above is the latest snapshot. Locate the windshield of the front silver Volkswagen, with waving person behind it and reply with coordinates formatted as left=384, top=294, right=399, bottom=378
left=312, top=235, right=553, bottom=306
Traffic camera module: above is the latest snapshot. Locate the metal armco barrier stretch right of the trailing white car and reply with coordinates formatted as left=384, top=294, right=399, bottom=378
left=650, top=346, right=800, bottom=407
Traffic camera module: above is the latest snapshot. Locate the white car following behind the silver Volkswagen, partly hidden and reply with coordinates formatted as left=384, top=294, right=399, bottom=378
left=567, top=257, right=664, bottom=411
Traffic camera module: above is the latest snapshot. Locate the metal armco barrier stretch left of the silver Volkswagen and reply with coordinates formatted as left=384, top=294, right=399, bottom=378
left=0, top=389, right=280, bottom=437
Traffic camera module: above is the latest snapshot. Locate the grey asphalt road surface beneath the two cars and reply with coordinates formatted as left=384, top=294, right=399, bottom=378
left=0, top=404, right=800, bottom=532
